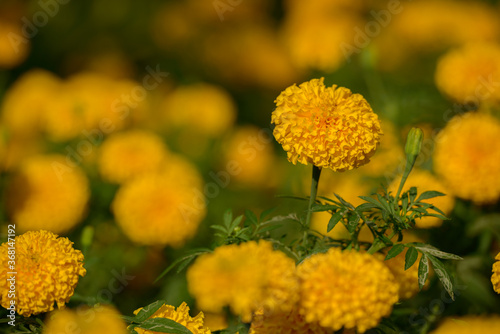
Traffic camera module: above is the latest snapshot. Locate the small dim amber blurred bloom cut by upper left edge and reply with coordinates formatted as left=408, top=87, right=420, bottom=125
left=0, top=20, right=30, bottom=69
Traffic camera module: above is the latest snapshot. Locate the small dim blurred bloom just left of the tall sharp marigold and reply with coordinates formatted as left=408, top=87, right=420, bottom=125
left=222, top=125, right=277, bottom=187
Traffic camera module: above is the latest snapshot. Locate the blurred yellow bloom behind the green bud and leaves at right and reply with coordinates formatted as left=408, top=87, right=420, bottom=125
left=388, top=169, right=455, bottom=228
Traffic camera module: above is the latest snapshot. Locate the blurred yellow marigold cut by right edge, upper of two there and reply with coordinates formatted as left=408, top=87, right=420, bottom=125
left=435, top=43, right=500, bottom=103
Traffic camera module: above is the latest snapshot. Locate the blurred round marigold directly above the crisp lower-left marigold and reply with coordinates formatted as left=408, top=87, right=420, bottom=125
left=7, top=154, right=90, bottom=234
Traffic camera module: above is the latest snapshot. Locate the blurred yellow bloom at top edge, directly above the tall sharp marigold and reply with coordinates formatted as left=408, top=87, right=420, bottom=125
left=282, top=0, right=365, bottom=72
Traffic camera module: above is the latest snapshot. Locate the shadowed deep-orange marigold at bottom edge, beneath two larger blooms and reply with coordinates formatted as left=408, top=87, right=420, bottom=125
left=249, top=308, right=331, bottom=334
